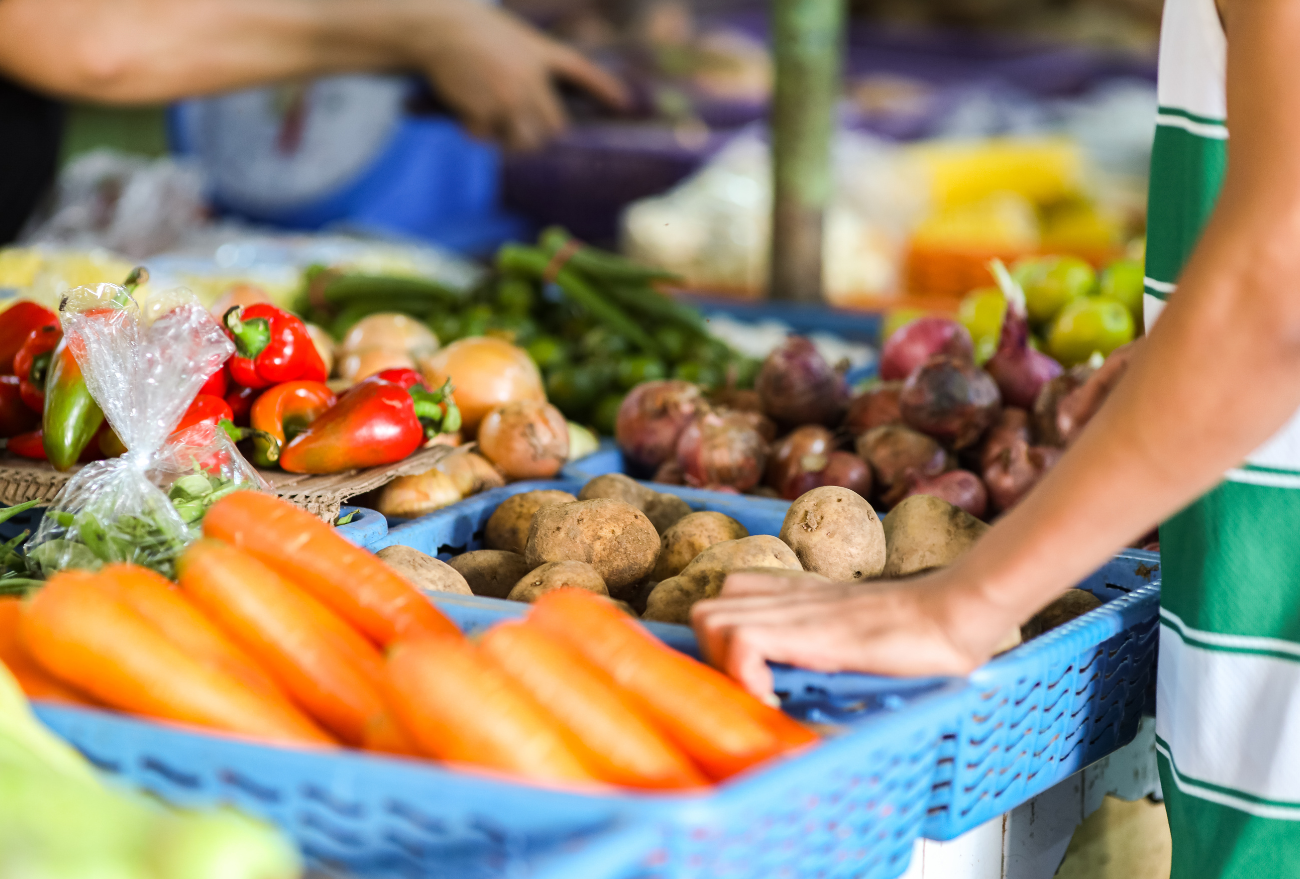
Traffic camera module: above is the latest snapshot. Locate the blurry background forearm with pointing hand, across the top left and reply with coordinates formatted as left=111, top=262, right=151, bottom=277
left=0, top=0, right=624, bottom=147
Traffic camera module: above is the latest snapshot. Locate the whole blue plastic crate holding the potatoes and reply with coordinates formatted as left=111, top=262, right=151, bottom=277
left=374, top=481, right=1160, bottom=840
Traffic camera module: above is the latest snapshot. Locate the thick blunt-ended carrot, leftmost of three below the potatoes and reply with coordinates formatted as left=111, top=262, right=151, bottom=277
left=387, top=637, right=598, bottom=781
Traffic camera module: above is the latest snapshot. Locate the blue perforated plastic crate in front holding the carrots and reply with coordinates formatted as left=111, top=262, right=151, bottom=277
left=38, top=587, right=969, bottom=879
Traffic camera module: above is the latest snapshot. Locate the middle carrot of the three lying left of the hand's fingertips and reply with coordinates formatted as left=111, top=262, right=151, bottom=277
left=478, top=622, right=709, bottom=788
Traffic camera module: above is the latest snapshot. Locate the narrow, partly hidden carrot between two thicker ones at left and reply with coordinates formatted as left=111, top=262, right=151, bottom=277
left=99, top=564, right=287, bottom=700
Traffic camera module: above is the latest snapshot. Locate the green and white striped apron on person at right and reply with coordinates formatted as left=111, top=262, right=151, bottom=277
left=1145, top=0, right=1300, bottom=879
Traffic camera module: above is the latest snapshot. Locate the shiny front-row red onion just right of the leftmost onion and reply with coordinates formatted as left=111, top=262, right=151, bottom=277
left=677, top=412, right=767, bottom=492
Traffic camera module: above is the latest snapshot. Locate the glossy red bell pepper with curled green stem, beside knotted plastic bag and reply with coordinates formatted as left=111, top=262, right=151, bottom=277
left=222, top=304, right=329, bottom=387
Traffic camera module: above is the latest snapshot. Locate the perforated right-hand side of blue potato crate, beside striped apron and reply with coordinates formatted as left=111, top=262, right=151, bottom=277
left=924, top=550, right=1160, bottom=840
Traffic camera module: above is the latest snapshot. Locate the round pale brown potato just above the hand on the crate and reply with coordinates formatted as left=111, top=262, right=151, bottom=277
left=781, top=485, right=885, bottom=581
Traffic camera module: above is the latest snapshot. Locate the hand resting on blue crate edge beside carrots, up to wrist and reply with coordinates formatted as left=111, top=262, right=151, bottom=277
left=692, top=568, right=1018, bottom=698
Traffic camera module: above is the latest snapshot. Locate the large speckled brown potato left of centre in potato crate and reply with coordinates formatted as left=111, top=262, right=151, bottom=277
left=524, top=498, right=659, bottom=599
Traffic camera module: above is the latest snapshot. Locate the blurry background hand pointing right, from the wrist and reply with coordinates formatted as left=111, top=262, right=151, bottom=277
left=413, top=0, right=628, bottom=150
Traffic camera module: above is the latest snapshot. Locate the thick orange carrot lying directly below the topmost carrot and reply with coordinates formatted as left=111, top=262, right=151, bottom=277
left=176, top=540, right=386, bottom=745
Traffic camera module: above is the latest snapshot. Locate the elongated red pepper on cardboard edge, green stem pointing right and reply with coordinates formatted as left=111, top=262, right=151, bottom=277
left=280, top=376, right=460, bottom=473
